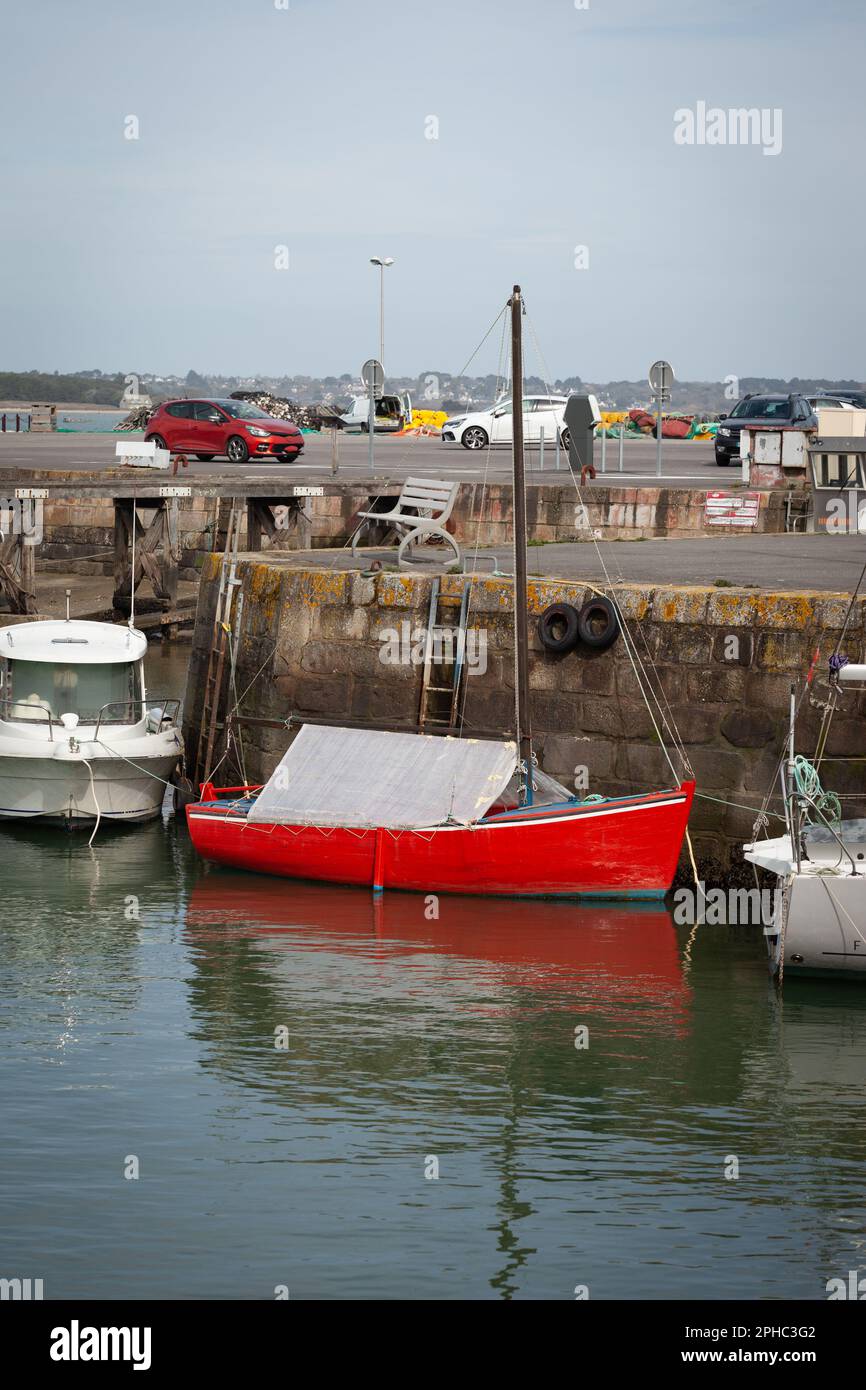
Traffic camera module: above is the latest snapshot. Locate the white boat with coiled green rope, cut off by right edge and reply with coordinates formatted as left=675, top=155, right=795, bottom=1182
left=744, top=664, right=866, bottom=980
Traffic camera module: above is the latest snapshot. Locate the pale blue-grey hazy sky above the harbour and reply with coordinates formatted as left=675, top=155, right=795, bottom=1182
left=0, top=0, right=866, bottom=381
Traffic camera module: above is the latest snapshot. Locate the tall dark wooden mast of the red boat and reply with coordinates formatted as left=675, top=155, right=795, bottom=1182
left=510, top=285, right=532, bottom=805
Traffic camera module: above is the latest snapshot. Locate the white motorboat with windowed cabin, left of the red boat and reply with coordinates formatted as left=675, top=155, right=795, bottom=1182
left=0, top=619, right=182, bottom=826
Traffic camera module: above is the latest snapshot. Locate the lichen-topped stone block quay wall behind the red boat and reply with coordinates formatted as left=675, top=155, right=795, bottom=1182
left=185, top=555, right=866, bottom=881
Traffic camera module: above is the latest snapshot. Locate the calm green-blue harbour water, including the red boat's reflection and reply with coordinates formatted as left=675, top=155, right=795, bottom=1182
left=0, top=646, right=866, bottom=1300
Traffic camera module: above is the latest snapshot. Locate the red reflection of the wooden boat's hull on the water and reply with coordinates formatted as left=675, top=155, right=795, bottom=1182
left=186, top=873, right=691, bottom=1024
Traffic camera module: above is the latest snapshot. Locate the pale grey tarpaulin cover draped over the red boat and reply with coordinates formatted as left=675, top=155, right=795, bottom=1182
left=247, top=724, right=517, bottom=830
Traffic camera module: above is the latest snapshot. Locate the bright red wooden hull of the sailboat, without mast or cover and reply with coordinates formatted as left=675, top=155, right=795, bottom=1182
left=186, top=781, right=695, bottom=898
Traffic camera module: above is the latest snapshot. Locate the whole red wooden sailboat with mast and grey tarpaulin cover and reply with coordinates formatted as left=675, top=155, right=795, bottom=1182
left=186, top=286, right=695, bottom=898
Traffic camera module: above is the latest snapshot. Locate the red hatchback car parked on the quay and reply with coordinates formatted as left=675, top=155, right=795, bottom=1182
left=145, top=400, right=303, bottom=463
